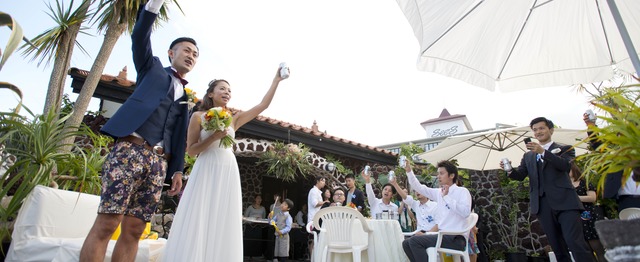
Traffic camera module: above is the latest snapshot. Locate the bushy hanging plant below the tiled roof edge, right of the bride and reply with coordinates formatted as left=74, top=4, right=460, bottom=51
left=258, top=142, right=313, bottom=181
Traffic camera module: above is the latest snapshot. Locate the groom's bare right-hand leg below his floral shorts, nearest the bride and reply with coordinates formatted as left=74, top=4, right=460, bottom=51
left=111, top=216, right=146, bottom=262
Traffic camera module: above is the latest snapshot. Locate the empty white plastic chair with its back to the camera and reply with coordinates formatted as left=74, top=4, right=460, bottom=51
left=313, top=206, right=375, bottom=262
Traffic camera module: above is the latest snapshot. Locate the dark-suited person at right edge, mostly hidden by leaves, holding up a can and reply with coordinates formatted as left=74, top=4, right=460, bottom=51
left=582, top=113, right=640, bottom=212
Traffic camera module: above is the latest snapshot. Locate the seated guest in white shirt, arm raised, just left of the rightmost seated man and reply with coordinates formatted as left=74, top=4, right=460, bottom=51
left=391, top=179, right=438, bottom=233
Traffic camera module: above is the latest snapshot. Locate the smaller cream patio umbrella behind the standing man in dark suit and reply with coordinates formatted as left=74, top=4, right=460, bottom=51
left=418, top=126, right=587, bottom=170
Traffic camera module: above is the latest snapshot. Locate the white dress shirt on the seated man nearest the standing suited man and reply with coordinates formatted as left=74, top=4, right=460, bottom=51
left=407, top=172, right=471, bottom=231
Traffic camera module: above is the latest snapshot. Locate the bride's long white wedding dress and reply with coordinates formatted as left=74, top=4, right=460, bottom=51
left=163, top=128, right=243, bottom=262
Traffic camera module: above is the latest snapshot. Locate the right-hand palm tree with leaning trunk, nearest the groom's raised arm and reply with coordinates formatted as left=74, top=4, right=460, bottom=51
left=63, top=0, right=182, bottom=150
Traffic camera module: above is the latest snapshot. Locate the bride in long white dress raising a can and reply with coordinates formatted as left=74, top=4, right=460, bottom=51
left=163, top=66, right=283, bottom=262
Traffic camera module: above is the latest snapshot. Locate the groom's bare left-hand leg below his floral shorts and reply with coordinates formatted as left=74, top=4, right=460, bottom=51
left=80, top=214, right=122, bottom=262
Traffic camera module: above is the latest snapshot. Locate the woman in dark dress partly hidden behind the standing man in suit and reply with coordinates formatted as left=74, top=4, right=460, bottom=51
left=569, top=162, right=606, bottom=262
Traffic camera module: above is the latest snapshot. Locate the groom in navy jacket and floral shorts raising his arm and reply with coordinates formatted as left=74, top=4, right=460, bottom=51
left=80, top=0, right=198, bottom=261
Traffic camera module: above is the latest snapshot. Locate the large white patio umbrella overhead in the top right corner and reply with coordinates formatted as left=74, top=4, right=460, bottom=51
left=396, top=0, right=640, bottom=91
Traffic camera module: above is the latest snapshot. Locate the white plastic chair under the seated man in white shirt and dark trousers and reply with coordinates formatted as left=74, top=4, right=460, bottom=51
left=427, top=213, right=478, bottom=262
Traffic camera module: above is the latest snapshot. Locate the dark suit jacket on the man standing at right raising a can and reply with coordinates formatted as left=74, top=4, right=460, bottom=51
left=509, top=143, right=584, bottom=214
